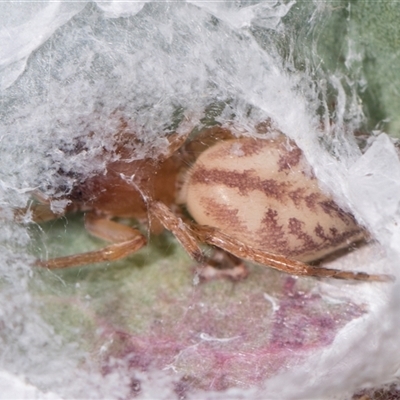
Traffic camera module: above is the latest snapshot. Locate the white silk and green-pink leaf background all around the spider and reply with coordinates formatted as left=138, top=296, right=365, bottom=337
left=0, top=0, right=400, bottom=399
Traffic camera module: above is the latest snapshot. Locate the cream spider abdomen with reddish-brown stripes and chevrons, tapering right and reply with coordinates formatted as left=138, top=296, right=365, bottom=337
left=184, top=138, right=364, bottom=262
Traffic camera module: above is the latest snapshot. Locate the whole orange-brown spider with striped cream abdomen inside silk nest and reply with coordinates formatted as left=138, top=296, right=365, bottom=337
left=25, top=127, right=388, bottom=281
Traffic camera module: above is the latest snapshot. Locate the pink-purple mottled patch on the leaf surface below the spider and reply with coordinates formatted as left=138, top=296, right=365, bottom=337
left=97, top=277, right=363, bottom=398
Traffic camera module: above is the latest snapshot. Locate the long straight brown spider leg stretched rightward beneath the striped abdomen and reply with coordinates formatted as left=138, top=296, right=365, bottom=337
left=191, top=224, right=393, bottom=282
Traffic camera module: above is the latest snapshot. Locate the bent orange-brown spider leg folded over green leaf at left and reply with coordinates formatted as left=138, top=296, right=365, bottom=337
left=35, top=213, right=147, bottom=269
